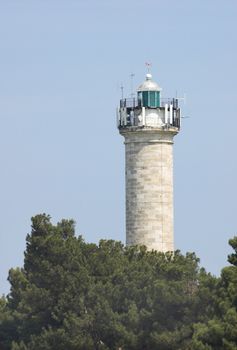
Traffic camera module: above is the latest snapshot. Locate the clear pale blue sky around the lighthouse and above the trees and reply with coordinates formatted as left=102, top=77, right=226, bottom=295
left=0, top=0, right=237, bottom=294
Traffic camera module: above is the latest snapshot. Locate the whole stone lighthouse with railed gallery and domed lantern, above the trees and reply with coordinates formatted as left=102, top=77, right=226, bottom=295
left=117, top=73, right=180, bottom=252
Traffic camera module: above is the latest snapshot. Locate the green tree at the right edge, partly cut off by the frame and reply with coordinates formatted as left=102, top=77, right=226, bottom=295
left=193, top=237, right=237, bottom=350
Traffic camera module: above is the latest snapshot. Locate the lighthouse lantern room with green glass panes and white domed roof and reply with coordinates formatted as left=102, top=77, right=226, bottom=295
left=137, top=73, right=162, bottom=108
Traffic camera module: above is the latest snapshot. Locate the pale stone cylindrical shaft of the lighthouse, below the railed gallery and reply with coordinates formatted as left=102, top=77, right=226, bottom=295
left=120, top=128, right=177, bottom=252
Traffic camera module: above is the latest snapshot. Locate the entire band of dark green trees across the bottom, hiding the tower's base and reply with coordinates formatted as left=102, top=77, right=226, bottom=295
left=0, top=214, right=237, bottom=350
